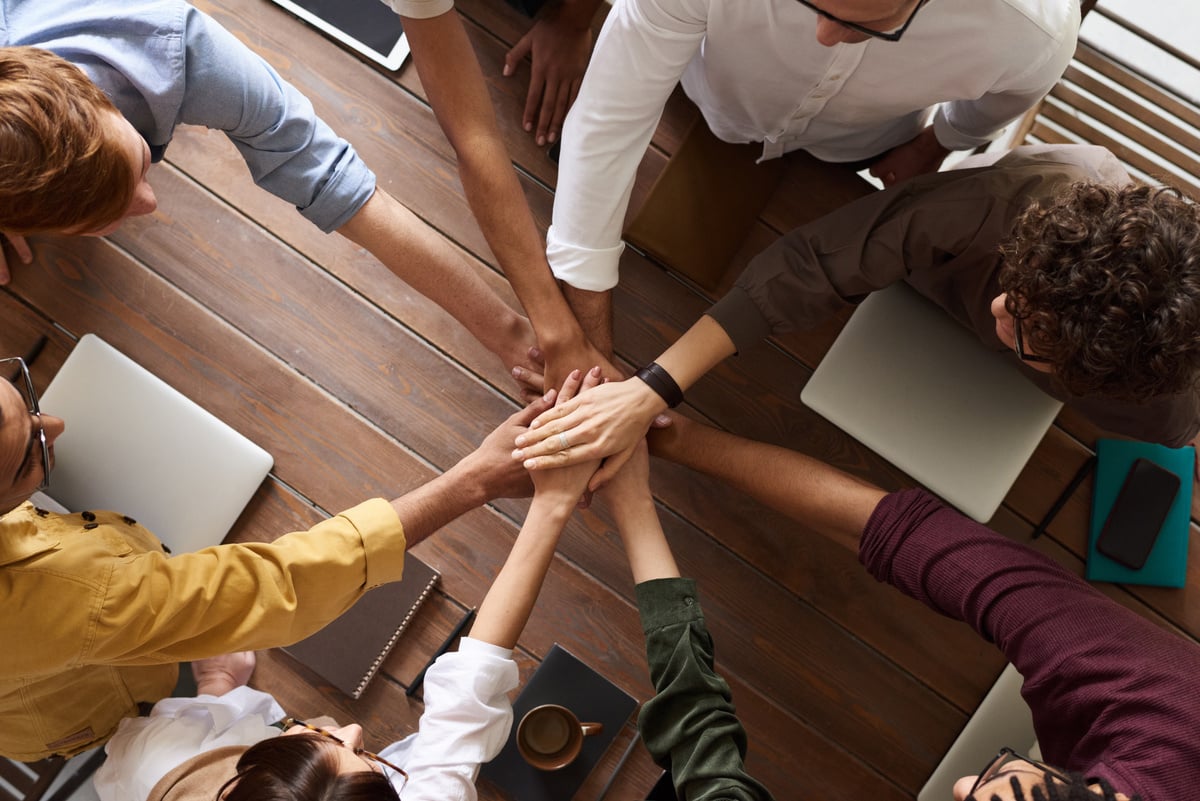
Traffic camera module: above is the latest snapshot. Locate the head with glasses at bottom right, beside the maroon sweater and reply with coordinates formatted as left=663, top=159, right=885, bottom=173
left=954, top=748, right=1141, bottom=801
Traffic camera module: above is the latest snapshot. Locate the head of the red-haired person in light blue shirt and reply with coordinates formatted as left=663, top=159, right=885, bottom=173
left=0, top=47, right=157, bottom=236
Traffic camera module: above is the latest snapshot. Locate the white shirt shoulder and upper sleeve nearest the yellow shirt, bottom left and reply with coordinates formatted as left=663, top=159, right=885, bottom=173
left=94, top=686, right=284, bottom=801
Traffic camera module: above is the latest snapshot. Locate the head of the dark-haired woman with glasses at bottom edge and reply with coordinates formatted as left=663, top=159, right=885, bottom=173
left=224, top=721, right=403, bottom=801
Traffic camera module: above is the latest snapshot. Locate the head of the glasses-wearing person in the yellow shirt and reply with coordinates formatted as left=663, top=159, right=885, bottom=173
left=0, top=357, right=65, bottom=513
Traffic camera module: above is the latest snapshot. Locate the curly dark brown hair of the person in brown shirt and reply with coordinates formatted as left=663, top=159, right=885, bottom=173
left=1000, top=182, right=1200, bottom=402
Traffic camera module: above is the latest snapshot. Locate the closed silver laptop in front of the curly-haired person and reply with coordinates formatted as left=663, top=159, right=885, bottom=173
left=800, top=283, right=1062, bottom=523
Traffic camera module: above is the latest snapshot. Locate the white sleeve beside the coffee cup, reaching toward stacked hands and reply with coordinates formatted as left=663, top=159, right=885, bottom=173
left=380, top=637, right=520, bottom=801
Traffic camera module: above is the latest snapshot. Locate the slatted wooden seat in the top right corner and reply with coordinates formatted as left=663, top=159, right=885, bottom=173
left=1012, top=2, right=1200, bottom=200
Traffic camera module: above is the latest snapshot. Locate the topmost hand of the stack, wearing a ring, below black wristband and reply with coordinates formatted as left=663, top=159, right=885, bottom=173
left=512, top=378, right=666, bottom=490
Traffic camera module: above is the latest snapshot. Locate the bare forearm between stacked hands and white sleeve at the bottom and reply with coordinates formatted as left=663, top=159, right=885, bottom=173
left=470, top=496, right=574, bottom=648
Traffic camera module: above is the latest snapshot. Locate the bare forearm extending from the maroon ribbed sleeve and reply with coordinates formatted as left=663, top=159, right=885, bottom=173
left=650, top=417, right=884, bottom=549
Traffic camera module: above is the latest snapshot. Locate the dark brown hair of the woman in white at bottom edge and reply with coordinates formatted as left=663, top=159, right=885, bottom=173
left=216, top=734, right=400, bottom=801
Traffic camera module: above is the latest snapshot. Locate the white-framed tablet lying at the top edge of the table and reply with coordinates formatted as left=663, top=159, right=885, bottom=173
left=271, top=0, right=408, bottom=72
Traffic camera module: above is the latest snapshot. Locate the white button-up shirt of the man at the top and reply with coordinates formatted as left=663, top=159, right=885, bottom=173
left=546, top=0, right=1079, bottom=291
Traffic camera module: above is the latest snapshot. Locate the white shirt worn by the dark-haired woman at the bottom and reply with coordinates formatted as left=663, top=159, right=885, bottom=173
left=95, top=637, right=520, bottom=801
